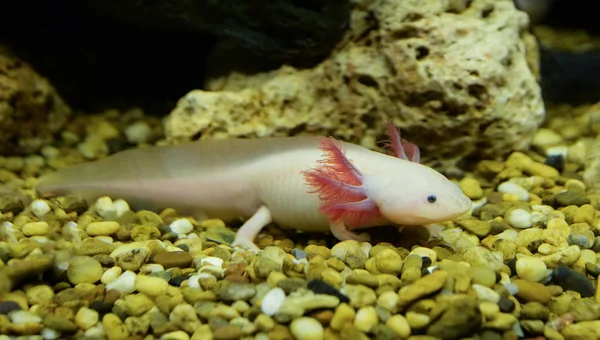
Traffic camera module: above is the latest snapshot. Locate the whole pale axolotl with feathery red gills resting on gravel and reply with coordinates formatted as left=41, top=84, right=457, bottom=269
left=37, top=123, right=472, bottom=250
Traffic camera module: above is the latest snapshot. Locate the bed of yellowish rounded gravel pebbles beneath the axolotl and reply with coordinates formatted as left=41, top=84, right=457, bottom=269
left=0, top=107, right=600, bottom=340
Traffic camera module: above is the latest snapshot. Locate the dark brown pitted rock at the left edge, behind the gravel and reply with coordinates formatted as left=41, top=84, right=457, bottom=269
left=0, top=54, right=71, bottom=155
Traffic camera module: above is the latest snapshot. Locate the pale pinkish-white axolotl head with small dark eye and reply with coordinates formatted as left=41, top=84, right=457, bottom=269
left=365, top=157, right=472, bottom=225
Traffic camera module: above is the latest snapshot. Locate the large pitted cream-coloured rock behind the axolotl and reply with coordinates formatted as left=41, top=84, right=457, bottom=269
left=166, top=0, right=554, bottom=170
